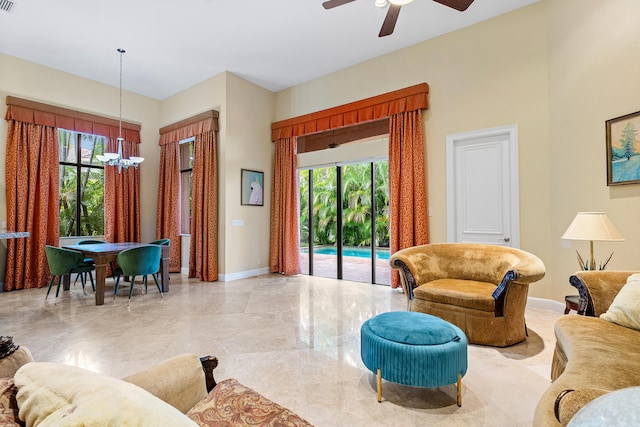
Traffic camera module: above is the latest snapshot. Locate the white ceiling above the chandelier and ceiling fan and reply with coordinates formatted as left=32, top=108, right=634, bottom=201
left=0, top=0, right=538, bottom=99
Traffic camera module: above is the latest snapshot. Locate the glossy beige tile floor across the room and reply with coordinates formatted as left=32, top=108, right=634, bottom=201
left=0, top=274, right=562, bottom=427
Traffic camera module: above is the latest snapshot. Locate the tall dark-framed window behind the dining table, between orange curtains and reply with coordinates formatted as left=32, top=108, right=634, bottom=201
left=58, top=129, right=107, bottom=237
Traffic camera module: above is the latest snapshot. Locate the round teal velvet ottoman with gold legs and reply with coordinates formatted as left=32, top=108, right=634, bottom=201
left=360, top=311, right=467, bottom=406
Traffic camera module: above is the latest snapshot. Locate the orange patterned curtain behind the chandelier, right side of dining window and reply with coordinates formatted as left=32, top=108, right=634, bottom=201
left=104, top=138, right=140, bottom=242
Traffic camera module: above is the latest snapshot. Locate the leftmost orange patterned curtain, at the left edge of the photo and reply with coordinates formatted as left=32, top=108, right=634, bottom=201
left=4, top=120, right=60, bottom=291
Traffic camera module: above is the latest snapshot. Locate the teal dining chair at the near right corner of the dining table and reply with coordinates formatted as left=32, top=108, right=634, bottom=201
left=113, top=245, right=164, bottom=302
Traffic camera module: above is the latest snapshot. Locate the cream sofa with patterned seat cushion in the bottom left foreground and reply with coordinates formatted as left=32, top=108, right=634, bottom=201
left=0, top=337, right=311, bottom=427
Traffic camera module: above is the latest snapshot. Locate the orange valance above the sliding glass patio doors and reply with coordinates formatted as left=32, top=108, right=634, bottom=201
left=271, top=83, right=429, bottom=141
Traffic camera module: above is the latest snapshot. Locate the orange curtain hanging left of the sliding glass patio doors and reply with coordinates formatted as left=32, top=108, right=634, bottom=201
left=269, top=138, right=300, bottom=276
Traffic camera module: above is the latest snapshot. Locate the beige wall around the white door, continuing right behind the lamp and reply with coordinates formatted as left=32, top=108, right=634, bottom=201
left=275, top=0, right=640, bottom=301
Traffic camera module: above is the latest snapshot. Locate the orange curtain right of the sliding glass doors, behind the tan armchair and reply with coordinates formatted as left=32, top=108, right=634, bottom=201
left=389, top=110, right=429, bottom=288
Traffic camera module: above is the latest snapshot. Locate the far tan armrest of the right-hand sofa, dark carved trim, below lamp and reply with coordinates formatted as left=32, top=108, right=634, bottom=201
left=569, top=270, right=639, bottom=317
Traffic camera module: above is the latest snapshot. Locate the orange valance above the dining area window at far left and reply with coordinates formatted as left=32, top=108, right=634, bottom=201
left=4, top=96, right=140, bottom=143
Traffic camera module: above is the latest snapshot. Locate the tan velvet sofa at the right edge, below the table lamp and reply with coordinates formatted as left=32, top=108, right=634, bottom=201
left=534, top=271, right=640, bottom=427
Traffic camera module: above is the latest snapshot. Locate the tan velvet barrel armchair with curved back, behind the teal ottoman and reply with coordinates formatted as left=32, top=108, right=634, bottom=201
left=389, top=243, right=545, bottom=347
